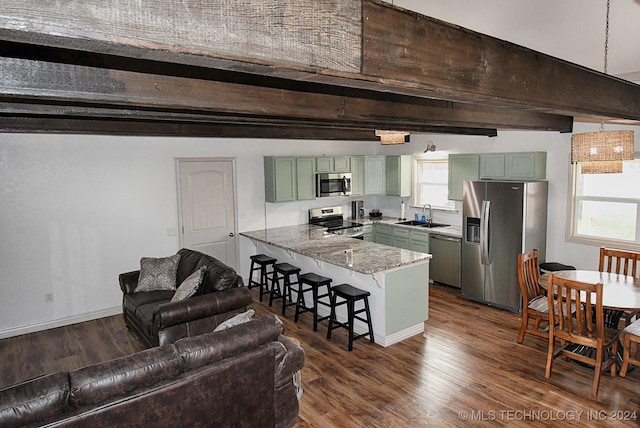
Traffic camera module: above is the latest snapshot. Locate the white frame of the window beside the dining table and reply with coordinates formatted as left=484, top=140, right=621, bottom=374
left=566, top=157, right=640, bottom=251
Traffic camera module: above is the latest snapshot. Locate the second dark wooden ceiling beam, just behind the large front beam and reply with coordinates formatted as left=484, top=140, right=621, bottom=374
left=0, top=52, right=572, bottom=132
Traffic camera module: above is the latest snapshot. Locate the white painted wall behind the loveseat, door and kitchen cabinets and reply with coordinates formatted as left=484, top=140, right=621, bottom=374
left=0, top=125, right=640, bottom=337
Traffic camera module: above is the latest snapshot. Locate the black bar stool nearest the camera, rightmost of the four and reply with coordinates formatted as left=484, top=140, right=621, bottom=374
left=327, top=284, right=375, bottom=351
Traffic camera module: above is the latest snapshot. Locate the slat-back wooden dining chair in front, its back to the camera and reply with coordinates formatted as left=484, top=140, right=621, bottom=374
left=545, top=273, right=620, bottom=398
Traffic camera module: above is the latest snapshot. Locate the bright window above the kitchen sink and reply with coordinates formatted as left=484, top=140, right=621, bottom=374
left=413, top=158, right=456, bottom=210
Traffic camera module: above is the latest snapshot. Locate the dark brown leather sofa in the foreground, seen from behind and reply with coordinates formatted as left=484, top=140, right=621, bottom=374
left=0, top=315, right=304, bottom=428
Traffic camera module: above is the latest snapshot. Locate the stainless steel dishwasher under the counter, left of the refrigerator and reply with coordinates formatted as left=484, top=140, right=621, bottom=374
left=429, top=233, right=461, bottom=288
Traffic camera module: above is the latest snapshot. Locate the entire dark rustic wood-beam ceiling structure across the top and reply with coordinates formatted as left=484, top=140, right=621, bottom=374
left=0, top=0, right=640, bottom=140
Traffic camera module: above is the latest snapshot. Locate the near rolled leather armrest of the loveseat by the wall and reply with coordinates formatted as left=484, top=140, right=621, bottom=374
left=153, top=287, right=253, bottom=335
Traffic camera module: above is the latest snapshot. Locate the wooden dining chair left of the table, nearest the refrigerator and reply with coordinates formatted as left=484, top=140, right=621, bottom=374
left=518, top=249, right=549, bottom=343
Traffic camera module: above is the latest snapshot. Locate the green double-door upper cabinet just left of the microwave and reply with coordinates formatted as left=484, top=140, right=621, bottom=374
left=264, top=156, right=315, bottom=202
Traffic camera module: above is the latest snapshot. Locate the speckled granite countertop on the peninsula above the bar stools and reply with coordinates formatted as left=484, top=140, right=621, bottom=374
left=240, top=224, right=431, bottom=274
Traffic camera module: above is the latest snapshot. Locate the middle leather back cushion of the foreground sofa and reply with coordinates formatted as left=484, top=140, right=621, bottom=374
left=69, top=345, right=182, bottom=407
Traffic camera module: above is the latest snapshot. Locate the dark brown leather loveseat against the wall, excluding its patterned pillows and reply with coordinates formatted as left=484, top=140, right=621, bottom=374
left=119, top=248, right=253, bottom=346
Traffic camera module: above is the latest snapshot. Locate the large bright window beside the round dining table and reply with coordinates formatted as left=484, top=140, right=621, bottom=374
left=571, top=158, right=640, bottom=249
